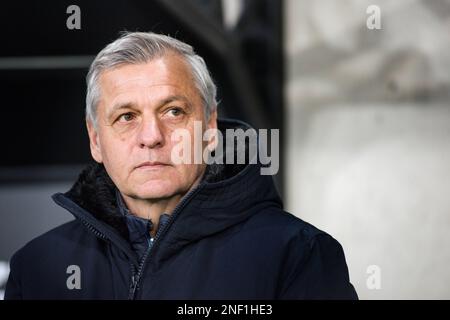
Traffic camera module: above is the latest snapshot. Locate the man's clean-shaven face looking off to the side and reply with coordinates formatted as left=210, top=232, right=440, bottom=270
left=87, top=54, right=217, bottom=199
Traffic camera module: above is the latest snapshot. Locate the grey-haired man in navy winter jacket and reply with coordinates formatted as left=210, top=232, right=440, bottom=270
left=5, top=33, right=357, bottom=299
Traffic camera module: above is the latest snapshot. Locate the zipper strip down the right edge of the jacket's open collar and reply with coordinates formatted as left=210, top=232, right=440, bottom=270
left=128, top=183, right=203, bottom=300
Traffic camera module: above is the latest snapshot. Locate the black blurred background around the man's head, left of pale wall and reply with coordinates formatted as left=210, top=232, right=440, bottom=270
left=0, top=0, right=283, bottom=276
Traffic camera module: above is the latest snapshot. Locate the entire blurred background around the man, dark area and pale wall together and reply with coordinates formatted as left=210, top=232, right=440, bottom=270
left=0, top=0, right=450, bottom=299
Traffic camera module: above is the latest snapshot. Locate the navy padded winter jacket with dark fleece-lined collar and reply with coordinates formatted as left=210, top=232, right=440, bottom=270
left=5, top=121, right=357, bottom=299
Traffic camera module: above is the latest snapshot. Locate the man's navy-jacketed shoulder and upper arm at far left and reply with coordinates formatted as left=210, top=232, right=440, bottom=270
left=5, top=220, right=106, bottom=299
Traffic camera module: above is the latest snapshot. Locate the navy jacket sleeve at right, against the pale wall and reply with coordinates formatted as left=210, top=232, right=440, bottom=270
left=279, top=233, right=358, bottom=299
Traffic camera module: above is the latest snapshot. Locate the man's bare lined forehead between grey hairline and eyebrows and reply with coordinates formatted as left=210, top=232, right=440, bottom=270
left=99, top=54, right=198, bottom=100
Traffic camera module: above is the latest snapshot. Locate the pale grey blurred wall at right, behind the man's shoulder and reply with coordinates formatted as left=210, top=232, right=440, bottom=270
left=285, top=0, right=450, bottom=299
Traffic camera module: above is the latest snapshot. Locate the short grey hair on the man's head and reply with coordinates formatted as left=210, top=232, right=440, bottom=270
left=86, top=32, right=217, bottom=127
